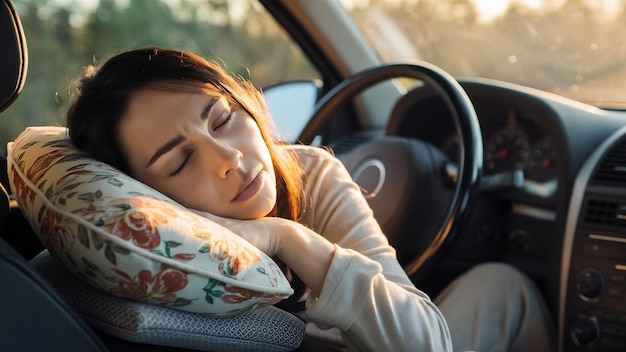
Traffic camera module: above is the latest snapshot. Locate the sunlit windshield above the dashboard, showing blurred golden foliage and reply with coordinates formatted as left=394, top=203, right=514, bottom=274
left=341, top=0, right=626, bottom=109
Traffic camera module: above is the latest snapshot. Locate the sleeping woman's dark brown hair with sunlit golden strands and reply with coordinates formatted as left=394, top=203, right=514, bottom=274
left=67, top=47, right=303, bottom=220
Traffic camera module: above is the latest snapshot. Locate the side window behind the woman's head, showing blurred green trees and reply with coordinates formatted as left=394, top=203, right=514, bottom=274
left=0, top=0, right=320, bottom=151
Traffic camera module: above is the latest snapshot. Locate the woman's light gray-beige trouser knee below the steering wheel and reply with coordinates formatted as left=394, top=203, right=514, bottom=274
left=435, top=263, right=556, bottom=352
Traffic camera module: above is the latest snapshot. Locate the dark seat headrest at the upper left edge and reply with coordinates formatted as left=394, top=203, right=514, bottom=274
left=0, top=0, right=28, bottom=112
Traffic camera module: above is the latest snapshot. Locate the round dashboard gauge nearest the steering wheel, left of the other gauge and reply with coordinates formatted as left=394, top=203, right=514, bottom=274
left=485, top=126, right=530, bottom=173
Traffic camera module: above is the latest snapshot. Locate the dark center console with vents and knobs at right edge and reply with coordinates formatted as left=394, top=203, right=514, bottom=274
left=559, top=129, right=626, bottom=352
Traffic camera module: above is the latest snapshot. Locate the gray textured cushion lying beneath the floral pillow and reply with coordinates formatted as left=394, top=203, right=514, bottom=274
left=30, top=252, right=305, bottom=351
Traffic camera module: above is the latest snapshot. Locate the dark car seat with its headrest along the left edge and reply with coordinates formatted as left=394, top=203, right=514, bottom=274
left=0, top=0, right=107, bottom=351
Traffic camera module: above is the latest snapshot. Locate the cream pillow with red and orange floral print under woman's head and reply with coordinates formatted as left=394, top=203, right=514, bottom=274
left=8, top=127, right=293, bottom=315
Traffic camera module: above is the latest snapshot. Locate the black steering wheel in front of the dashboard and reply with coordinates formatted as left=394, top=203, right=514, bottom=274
left=299, top=62, right=483, bottom=279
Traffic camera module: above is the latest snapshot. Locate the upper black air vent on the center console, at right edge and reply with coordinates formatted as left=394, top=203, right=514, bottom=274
left=591, top=138, right=626, bottom=188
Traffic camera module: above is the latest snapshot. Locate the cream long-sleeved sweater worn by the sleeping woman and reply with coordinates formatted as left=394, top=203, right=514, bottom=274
left=294, top=146, right=452, bottom=351
